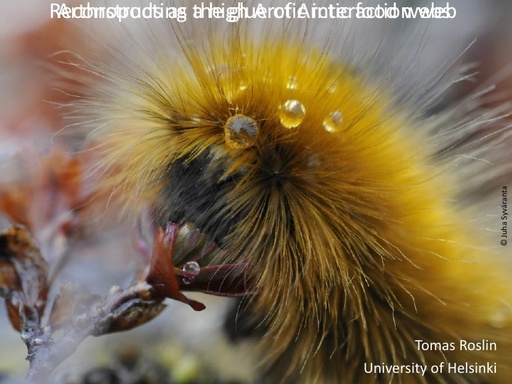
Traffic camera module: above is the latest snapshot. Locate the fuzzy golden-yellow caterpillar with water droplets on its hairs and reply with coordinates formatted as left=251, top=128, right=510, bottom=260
left=66, top=0, right=512, bottom=384
